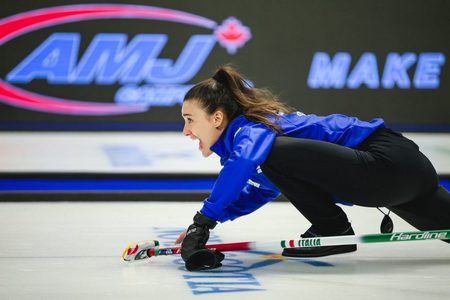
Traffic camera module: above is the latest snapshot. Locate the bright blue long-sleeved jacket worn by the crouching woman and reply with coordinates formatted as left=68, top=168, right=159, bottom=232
left=200, top=112, right=384, bottom=222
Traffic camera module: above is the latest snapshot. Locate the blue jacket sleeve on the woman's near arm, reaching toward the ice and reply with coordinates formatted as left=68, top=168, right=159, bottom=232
left=200, top=125, right=276, bottom=222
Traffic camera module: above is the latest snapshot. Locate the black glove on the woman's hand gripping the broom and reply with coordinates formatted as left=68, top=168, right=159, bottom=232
left=181, top=212, right=225, bottom=271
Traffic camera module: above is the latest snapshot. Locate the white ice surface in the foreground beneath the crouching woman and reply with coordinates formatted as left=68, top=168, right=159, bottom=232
left=0, top=202, right=450, bottom=300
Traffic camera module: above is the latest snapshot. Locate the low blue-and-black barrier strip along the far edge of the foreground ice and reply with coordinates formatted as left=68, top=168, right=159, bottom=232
left=0, top=174, right=450, bottom=202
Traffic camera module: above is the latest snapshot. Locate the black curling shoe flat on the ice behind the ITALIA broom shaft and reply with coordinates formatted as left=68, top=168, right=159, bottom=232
left=281, top=224, right=356, bottom=258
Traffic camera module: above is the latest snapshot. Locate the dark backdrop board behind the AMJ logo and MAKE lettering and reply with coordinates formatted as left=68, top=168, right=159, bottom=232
left=0, top=0, right=450, bottom=131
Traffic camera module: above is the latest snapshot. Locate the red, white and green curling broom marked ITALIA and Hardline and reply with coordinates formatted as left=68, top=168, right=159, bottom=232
left=122, top=229, right=450, bottom=262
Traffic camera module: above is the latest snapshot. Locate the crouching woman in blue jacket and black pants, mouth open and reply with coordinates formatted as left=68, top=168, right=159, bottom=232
left=176, top=66, right=450, bottom=270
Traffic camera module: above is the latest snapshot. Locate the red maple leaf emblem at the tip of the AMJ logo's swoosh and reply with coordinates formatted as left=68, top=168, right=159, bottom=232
left=214, top=17, right=252, bottom=54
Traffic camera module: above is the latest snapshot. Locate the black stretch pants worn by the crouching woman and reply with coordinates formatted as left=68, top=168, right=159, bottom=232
left=261, top=128, right=450, bottom=234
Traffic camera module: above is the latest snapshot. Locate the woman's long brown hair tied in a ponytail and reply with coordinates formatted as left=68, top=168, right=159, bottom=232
left=184, top=66, right=292, bottom=132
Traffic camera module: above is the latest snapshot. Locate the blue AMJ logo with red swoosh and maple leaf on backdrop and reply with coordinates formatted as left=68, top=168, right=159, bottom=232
left=0, top=4, right=251, bottom=115
